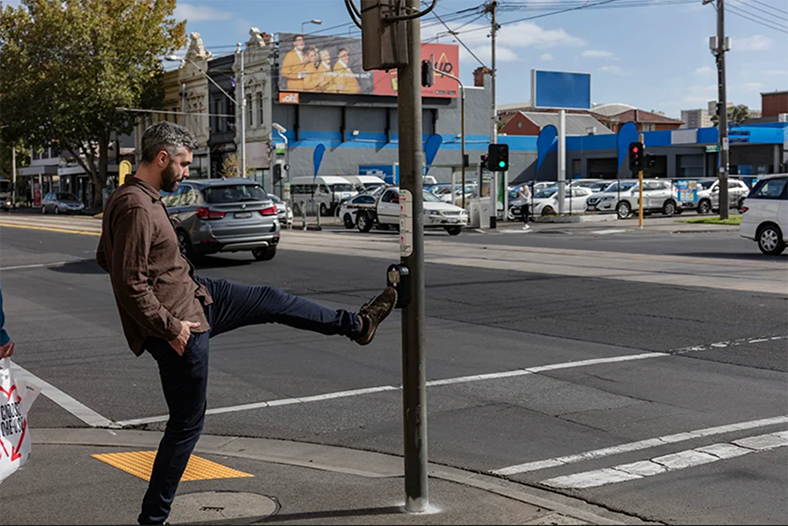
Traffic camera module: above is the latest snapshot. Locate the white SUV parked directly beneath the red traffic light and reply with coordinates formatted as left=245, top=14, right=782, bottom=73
left=586, top=179, right=681, bottom=219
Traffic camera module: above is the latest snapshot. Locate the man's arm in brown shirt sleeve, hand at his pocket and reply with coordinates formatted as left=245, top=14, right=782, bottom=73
left=110, top=207, right=182, bottom=342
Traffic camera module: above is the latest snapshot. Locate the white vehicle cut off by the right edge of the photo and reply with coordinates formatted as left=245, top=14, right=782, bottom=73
left=739, top=174, right=788, bottom=256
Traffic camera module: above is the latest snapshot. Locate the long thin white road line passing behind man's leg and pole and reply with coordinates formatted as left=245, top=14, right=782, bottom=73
left=117, top=352, right=670, bottom=427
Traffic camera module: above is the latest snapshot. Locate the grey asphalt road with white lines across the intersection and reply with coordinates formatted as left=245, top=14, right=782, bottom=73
left=0, top=221, right=788, bottom=524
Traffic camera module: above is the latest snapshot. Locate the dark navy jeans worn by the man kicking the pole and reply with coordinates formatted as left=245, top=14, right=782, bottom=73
left=137, top=278, right=362, bottom=524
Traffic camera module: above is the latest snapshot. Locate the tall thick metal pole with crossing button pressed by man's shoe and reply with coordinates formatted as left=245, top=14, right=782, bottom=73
left=397, top=0, right=429, bottom=513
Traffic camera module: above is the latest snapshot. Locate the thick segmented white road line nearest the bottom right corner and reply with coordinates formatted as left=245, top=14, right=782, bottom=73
left=540, top=431, right=788, bottom=489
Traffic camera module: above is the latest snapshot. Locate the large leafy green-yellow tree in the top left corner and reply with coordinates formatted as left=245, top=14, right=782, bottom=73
left=0, top=0, right=186, bottom=210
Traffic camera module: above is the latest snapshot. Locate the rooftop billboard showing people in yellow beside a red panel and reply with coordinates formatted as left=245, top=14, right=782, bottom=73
left=279, top=33, right=460, bottom=98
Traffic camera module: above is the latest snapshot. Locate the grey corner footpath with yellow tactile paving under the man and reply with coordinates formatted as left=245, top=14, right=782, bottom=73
left=0, top=428, right=653, bottom=524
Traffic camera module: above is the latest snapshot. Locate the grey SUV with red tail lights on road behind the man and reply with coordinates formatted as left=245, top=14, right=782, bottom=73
left=162, top=178, right=281, bottom=261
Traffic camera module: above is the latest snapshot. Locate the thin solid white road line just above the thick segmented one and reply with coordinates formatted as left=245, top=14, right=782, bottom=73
left=491, top=416, right=788, bottom=475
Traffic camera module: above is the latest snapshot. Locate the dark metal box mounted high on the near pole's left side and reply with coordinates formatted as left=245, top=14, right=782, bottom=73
left=362, top=0, right=409, bottom=71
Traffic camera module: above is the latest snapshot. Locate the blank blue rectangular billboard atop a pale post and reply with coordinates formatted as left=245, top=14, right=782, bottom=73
left=531, top=69, right=591, bottom=110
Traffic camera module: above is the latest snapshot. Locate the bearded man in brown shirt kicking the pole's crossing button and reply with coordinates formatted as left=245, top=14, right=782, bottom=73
left=96, top=121, right=397, bottom=524
